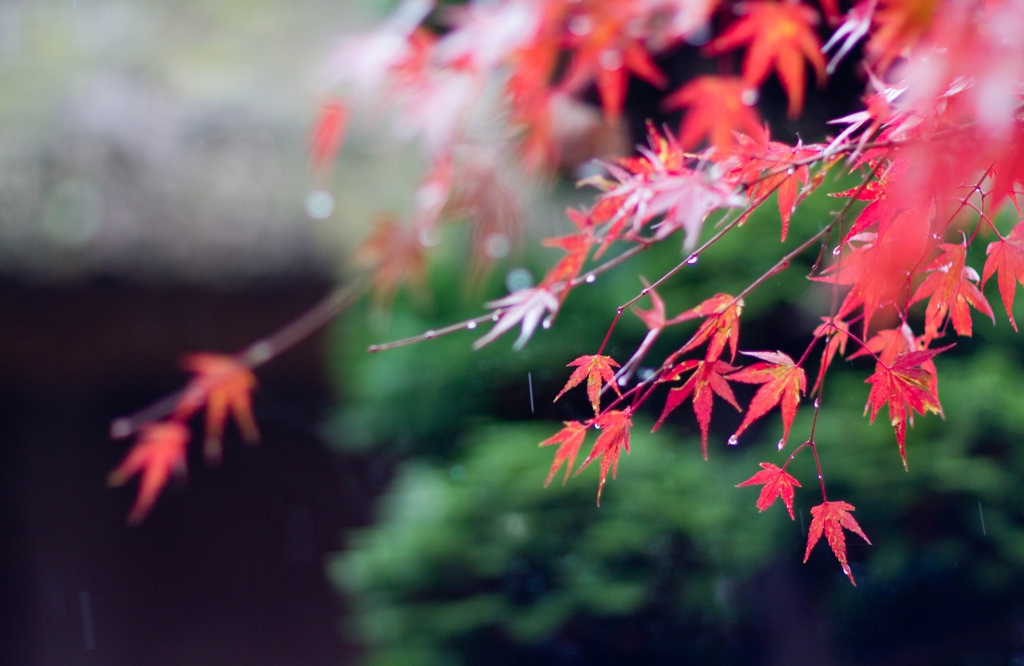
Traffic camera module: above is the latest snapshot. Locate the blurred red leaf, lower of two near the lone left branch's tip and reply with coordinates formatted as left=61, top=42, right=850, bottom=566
left=106, top=421, right=188, bottom=525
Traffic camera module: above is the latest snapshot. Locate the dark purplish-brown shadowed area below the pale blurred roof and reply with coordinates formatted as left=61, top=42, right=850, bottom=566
left=0, top=280, right=383, bottom=666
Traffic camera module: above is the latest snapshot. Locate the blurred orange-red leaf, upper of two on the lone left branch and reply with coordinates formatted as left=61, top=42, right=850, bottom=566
left=175, top=353, right=259, bottom=461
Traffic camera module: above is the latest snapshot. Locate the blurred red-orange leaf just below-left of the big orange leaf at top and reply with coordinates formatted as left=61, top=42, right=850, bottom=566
left=663, top=76, right=765, bottom=155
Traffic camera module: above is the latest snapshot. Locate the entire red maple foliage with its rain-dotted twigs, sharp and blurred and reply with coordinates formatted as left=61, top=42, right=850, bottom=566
left=110, top=0, right=1024, bottom=581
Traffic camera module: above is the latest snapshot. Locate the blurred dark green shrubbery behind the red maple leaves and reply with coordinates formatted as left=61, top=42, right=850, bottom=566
left=323, top=175, right=1024, bottom=664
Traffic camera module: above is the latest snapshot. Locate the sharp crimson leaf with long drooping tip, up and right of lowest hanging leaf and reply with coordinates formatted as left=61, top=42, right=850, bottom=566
left=864, top=345, right=952, bottom=467
